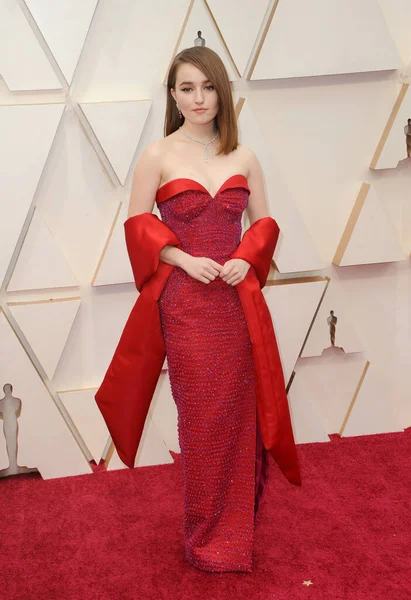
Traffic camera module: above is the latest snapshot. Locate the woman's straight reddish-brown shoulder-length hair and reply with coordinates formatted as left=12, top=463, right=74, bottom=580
left=164, top=46, right=238, bottom=154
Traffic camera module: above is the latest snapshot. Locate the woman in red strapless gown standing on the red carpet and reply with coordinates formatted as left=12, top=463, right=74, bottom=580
left=96, top=46, right=301, bottom=572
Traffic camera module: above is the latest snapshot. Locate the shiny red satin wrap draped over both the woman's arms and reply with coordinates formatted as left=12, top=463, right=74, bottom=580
left=95, top=213, right=301, bottom=485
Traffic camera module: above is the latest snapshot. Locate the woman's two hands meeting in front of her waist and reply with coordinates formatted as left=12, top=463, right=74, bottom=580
left=184, top=256, right=251, bottom=285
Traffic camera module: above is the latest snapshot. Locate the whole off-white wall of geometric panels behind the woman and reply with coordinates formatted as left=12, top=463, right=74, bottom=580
left=0, top=0, right=411, bottom=478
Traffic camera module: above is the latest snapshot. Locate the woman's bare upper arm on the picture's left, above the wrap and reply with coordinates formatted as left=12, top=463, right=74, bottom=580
left=128, top=142, right=161, bottom=217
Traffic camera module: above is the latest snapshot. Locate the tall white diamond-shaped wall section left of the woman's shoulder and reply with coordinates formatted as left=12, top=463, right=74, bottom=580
left=30, top=110, right=121, bottom=286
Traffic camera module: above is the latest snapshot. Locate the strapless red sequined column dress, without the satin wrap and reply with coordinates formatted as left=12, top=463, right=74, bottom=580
left=156, top=174, right=267, bottom=572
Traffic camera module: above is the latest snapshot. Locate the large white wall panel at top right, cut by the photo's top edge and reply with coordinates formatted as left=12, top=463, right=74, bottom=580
left=252, top=0, right=402, bottom=80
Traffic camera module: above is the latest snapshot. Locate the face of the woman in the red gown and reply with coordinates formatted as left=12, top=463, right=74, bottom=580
left=170, top=63, right=219, bottom=125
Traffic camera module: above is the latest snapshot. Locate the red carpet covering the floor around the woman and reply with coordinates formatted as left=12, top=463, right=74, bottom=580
left=0, top=428, right=411, bottom=600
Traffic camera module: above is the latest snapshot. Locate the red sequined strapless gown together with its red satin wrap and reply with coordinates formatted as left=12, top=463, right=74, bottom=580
left=95, top=175, right=301, bottom=571
